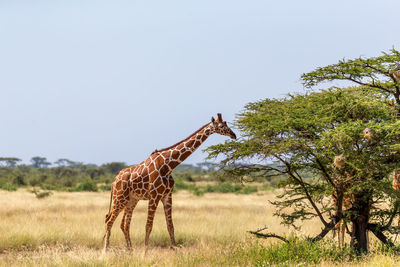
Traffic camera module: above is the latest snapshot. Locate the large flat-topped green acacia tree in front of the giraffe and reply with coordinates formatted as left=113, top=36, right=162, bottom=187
left=208, top=50, right=400, bottom=251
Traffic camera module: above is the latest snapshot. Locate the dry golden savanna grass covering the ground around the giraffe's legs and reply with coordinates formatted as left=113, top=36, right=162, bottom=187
left=0, top=190, right=398, bottom=266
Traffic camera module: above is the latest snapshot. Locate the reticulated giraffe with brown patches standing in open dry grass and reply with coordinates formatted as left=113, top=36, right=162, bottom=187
left=104, top=113, right=236, bottom=252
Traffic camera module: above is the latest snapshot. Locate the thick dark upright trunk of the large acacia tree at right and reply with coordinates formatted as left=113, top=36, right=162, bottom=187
left=350, top=191, right=372, bottom=252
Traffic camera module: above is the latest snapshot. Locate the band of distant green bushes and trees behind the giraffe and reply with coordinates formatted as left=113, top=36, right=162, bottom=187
left=0, top=157, right=272, bottom=195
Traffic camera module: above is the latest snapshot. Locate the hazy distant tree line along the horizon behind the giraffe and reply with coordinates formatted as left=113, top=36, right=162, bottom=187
left=0, top=156, right=231, bottom=191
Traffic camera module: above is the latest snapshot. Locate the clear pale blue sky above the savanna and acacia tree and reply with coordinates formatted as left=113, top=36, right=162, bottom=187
left=0, top=0, right=400, bottom=164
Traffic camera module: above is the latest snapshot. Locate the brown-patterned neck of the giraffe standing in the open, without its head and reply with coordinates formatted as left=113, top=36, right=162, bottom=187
left=158, top=124, right=213, bottom=171
